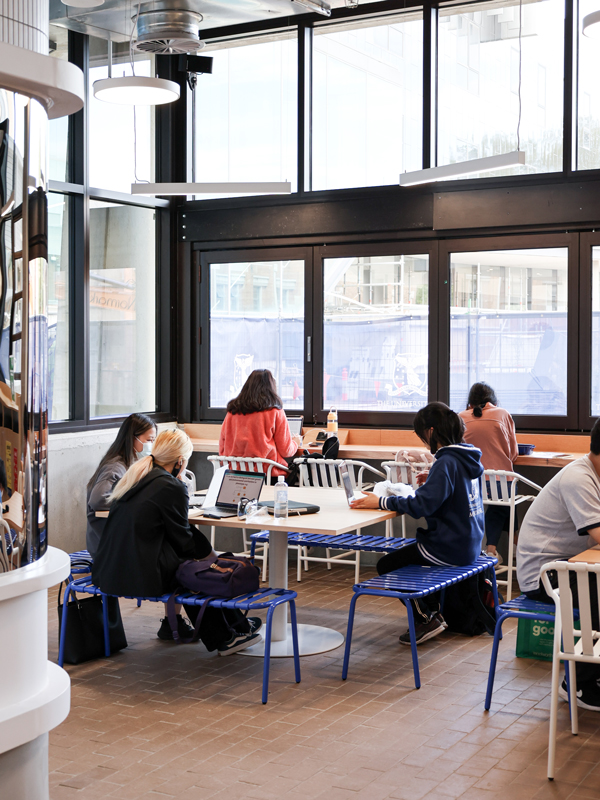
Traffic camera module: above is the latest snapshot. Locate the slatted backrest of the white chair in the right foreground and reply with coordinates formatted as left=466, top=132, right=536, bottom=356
left=541, top=561, right=600, bottom=661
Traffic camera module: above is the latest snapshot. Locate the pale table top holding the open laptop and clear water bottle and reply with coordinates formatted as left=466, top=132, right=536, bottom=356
left=189, top=486, right=397, bottom=535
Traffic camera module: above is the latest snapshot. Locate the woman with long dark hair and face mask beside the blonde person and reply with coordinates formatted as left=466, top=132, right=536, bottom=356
left=85, top=414, right=156, bottom=556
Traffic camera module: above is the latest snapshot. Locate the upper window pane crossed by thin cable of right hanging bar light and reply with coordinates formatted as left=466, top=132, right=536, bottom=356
left=438, top=0, right=564, bottom=177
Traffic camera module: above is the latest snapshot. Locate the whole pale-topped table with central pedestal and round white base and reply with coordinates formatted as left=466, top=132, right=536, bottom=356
left=189, top=486, right=396, bottom=658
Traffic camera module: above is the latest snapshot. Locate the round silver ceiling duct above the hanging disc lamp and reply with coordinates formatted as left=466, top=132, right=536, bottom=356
left=134, top=8, right=204, bottom=55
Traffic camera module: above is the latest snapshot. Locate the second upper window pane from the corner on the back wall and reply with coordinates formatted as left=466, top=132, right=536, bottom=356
left=312, top=14, right=423, bottom=189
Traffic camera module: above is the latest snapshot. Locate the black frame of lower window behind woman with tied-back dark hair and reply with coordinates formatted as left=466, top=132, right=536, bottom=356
left=438, top=233, right=580, bottom=431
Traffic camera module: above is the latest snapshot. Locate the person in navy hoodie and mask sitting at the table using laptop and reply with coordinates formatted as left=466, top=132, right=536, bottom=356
left=352, top=402, right=484, bottom=645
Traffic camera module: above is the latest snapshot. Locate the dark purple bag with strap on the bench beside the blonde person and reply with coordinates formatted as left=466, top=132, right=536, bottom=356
left=167, top=553, right=260, bottom=644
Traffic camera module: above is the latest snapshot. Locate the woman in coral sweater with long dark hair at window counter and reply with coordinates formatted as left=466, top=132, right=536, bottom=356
left=219, top=369, right=302, bottom=476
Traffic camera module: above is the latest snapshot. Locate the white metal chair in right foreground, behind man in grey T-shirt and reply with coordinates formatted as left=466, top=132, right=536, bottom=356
left=541, top=561, right=600, bottom=780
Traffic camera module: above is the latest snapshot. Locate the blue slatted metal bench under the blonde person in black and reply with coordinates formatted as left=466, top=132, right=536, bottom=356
left=58, top=576, right=300, bottom=703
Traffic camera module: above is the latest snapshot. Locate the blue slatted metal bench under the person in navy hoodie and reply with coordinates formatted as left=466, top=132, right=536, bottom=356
left=342, top=552, right=498, bottom=689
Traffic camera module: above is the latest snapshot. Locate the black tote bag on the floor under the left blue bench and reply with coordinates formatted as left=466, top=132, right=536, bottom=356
left=58, top=581, right=127, bottom=664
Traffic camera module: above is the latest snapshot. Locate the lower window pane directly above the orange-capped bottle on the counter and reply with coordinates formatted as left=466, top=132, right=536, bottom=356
left=323, top=255, right=429, bottom=412
